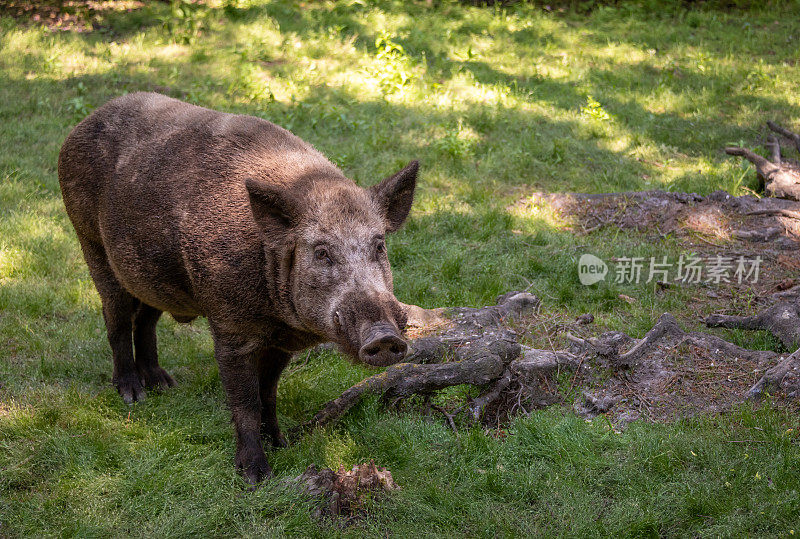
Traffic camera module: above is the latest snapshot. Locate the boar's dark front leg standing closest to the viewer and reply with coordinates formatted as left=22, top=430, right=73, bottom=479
left=212, top=330, right=272, bottom=485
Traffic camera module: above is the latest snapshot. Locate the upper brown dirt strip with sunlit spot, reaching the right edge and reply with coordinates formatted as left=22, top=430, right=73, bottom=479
left=516, top=191, right=800, bottom=332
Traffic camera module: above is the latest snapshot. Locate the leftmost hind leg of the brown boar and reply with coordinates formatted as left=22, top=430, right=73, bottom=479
left=81, top=241, right=145, bottom=404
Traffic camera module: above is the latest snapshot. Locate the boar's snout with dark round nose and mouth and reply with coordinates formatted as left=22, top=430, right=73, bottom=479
left=334, top=301, right=408, bottom=367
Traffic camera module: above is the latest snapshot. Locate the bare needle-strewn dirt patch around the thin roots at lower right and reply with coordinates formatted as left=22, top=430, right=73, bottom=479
left=573, top=314, right=784, bottom=425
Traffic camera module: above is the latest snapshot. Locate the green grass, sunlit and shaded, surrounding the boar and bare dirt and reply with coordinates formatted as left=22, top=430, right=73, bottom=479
left=0, top=0, right=800, bottom=536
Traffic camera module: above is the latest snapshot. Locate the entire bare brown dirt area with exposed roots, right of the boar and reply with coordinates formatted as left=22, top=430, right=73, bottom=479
left=301, top=191, right=800, bottom=429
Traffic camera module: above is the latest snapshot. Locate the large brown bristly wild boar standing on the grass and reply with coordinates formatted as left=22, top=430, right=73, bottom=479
left=58, top=93, right=419, bottom=483
